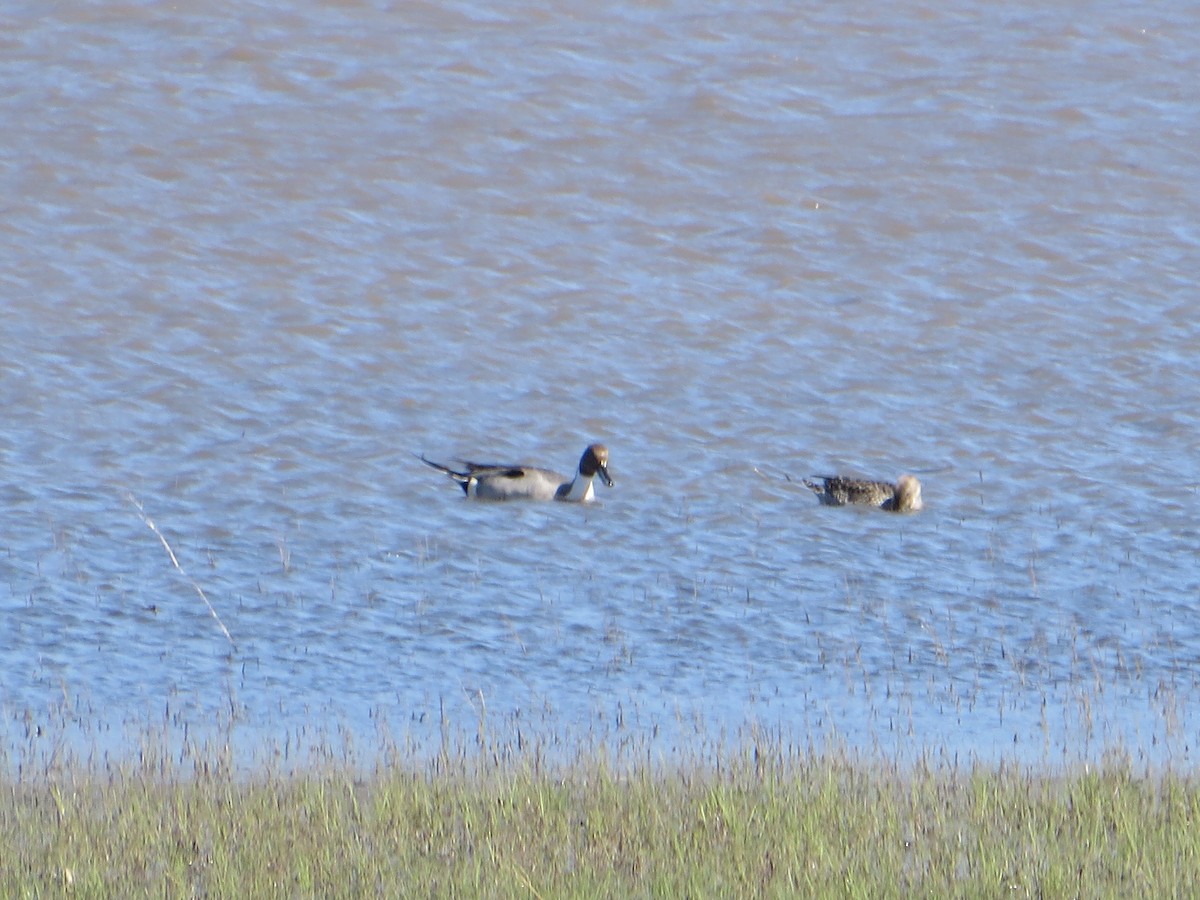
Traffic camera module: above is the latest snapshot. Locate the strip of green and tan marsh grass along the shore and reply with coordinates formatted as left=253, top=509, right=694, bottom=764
left=7, top=739, right=1200, bottom=898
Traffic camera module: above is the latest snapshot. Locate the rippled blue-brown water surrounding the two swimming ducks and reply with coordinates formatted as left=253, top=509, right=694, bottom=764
left=0, top=0, right=1200, bottom=762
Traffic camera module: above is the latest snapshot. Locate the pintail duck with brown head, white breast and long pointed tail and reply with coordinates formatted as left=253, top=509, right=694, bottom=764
left=418, top=444, right=613, bottom=503
